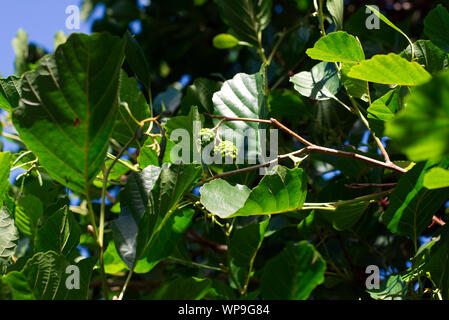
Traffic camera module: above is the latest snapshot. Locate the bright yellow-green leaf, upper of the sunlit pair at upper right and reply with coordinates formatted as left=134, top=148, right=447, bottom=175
left=306, top=31, right=365, bottom=62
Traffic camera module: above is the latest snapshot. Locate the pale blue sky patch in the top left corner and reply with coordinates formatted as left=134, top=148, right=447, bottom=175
left=0, top=0, right=103, bottom=77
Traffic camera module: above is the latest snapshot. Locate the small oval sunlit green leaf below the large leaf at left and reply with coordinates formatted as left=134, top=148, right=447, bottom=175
left=15, top=194, right=44, bottom=237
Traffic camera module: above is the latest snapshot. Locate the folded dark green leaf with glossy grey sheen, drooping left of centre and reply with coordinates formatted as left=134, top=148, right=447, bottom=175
left=112, top=164, right=201, bottom=273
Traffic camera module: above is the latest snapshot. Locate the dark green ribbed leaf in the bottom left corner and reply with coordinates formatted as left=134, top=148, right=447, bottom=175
left=2, top=251, right=94, bottom=300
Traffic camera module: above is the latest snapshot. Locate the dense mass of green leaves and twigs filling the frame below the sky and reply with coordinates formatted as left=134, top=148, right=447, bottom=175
left=0, top=0, right=449, bottom=299
